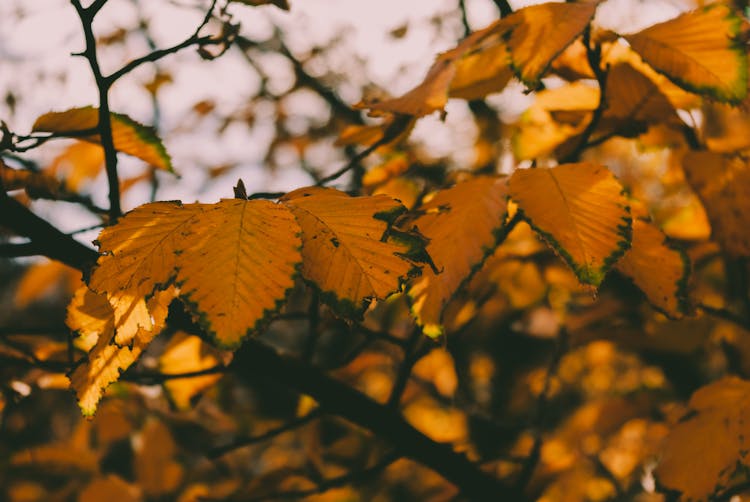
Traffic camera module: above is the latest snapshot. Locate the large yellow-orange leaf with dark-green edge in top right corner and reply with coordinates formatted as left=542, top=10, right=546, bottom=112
left=624, top=3, right=747, bottom=104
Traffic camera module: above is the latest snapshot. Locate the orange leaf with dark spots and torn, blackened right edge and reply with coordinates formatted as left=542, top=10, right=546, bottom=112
left=281, top=187, right=413, bottom=313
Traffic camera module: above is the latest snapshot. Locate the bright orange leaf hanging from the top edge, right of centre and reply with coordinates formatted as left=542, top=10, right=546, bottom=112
left=502, top=1, right=599, bottom=88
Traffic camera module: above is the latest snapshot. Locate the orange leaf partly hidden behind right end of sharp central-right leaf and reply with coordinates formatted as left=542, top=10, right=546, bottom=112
left=615, top=219, right=690, bottom=318
